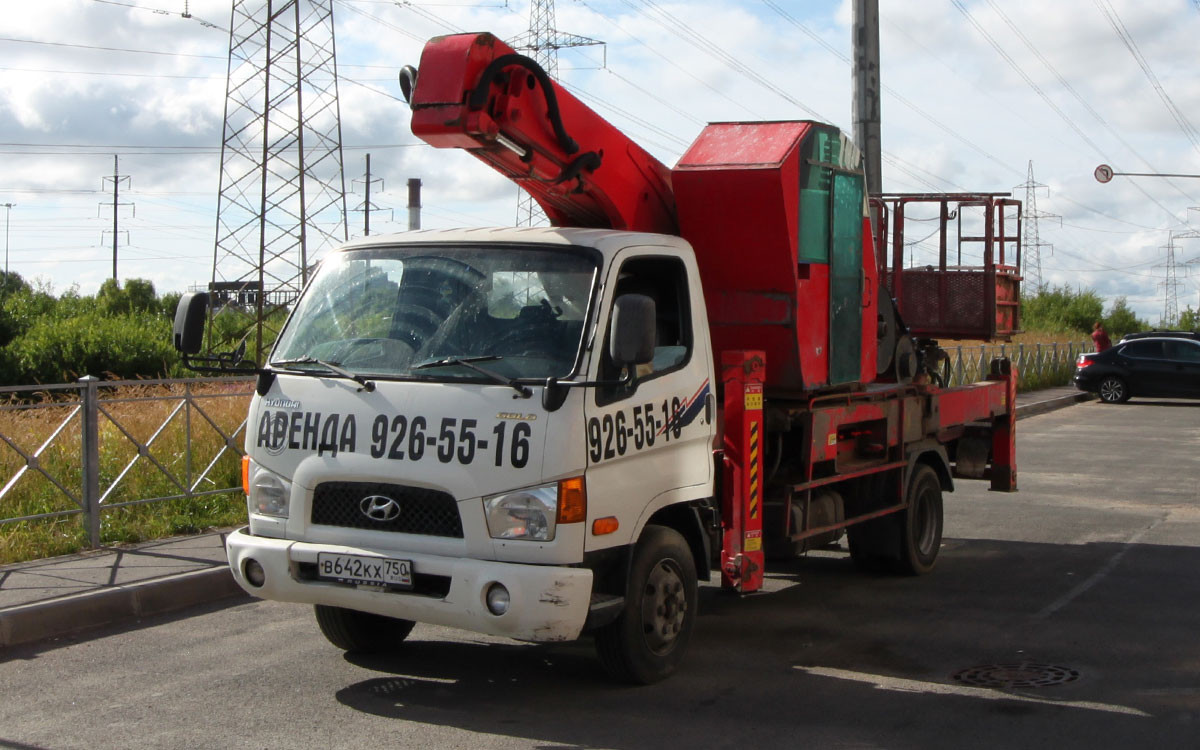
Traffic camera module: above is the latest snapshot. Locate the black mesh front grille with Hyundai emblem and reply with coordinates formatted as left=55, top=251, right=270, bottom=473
left=312, top=481, right=462, bottom=539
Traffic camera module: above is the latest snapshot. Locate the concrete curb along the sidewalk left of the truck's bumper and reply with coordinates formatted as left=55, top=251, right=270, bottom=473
left=0, top=565, right=250, bottom=648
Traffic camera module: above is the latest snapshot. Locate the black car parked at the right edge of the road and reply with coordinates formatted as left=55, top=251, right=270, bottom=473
left=1075, top=334, right=1200, bottom=403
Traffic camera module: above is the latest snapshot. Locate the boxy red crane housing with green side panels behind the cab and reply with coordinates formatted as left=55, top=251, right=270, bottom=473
left=672, top=122, right=876, bottom=395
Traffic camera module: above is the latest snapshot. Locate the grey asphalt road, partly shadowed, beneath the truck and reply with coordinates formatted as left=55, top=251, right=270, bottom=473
left=0, top=401, right=1200, bottom=750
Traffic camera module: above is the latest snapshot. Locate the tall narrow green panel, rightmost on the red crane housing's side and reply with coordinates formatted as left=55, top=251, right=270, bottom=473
left=829, top=173, right=863, bottom=383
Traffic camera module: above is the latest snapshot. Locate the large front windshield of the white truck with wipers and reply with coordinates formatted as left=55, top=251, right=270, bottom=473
left=271, top=245, right=598, bottom=380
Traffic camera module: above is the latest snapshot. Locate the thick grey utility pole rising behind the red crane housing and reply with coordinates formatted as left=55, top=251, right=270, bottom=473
left=852, top=0, right=883, bottom=201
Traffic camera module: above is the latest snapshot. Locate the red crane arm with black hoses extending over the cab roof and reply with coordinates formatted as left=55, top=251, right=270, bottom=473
left=410, top=34, right=679, bottom=234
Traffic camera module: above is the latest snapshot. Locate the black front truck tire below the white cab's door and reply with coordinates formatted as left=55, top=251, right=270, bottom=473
left=595, top=526, right=696, bottom=685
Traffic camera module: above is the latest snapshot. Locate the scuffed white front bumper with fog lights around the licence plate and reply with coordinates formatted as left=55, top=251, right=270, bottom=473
left=226, top=529, right=592, bottom=641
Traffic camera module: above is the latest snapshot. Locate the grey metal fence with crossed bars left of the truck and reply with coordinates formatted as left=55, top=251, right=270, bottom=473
left=0, top=376, right=254, bottom=547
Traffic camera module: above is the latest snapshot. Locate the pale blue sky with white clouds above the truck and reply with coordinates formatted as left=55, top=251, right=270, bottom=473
left=0, top=0, right=1200, bottom=324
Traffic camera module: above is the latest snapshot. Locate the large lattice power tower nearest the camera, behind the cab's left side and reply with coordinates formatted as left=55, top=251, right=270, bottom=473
left=210, top=0, right=347, bottom=361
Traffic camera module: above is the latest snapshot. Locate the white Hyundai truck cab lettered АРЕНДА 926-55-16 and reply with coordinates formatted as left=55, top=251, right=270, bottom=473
left=218, top=228, right=716, bottom=652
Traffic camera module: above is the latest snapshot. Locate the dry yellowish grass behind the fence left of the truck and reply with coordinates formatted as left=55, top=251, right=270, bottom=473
left=0, top=382, right=252, bottom=563
